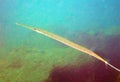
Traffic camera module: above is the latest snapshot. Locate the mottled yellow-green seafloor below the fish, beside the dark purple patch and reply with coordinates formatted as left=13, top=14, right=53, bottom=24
left=0, top=46, right=92, bottom=82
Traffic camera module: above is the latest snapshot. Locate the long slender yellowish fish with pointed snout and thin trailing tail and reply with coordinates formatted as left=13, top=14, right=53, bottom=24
left=16, top=23, right=120, bottom=72
